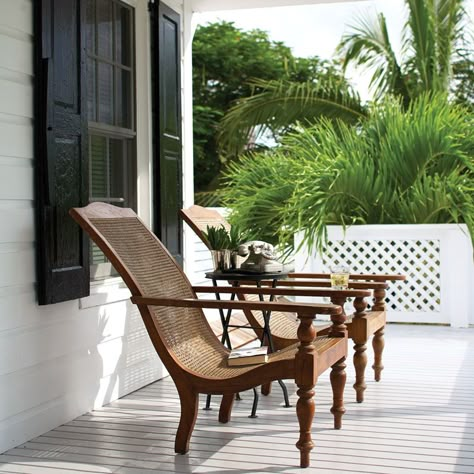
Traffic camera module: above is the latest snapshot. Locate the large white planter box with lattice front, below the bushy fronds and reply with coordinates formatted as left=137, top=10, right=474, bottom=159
left=295, top=224, right=474, bottom=327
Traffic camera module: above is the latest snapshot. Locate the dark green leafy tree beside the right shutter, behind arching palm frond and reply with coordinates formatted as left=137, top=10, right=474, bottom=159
left=193, top=22, right=352, bottom=198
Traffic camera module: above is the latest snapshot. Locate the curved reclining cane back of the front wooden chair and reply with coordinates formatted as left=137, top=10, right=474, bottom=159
left=70, top=203, right=225, bottom=374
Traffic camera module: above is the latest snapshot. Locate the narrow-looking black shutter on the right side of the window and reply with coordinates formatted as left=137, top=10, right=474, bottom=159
left=150, top=2, right=183, bottom=264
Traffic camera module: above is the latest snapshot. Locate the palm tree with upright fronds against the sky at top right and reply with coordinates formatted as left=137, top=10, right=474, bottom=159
left=338, top=0, right=467, bottom=105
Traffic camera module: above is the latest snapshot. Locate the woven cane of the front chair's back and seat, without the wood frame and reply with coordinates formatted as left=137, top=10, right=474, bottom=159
left=91, top=217, right=334, bottom=379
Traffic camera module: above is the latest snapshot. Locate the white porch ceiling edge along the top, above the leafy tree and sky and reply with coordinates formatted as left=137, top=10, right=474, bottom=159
left=191, top=0, right=363, bottom=12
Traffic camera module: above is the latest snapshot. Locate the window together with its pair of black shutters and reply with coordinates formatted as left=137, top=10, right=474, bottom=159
left=32, top=0, right=183, bottom=305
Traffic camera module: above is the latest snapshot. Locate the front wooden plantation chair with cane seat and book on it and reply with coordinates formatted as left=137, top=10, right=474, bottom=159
left=70, top=203, right=347, bottom=467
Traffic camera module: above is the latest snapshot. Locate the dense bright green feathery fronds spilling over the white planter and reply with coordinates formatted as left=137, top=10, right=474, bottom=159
left=223, top=94, right=474, bottom=254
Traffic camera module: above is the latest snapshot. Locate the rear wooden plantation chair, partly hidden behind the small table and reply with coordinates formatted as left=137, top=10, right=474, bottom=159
left=180, top=206, right=405, bottom=403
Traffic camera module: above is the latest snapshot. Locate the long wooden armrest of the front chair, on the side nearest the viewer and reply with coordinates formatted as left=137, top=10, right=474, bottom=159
left=130, top=296, right=342, bottom=316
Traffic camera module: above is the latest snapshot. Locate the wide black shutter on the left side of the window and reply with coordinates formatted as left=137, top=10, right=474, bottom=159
left=34, top=0, right=89, bottom=304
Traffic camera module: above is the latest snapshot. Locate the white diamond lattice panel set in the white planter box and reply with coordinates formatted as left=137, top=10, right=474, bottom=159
left=322, top=240, right=441, bottom=312
